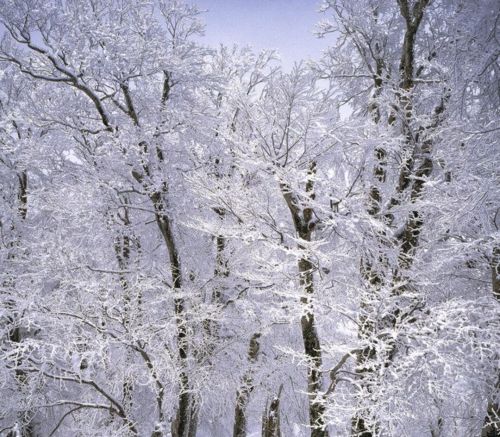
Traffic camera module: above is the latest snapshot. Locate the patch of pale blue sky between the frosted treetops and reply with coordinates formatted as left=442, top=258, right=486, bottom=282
left=190, top=0, right=331, bottom=67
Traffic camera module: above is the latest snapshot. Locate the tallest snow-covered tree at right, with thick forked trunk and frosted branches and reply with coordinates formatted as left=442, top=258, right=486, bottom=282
left=318, top=0, right=499, bottom=437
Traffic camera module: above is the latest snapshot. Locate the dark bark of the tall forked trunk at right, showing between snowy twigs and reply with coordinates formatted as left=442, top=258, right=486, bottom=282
left=351, top=0, right=430, bottom=437
